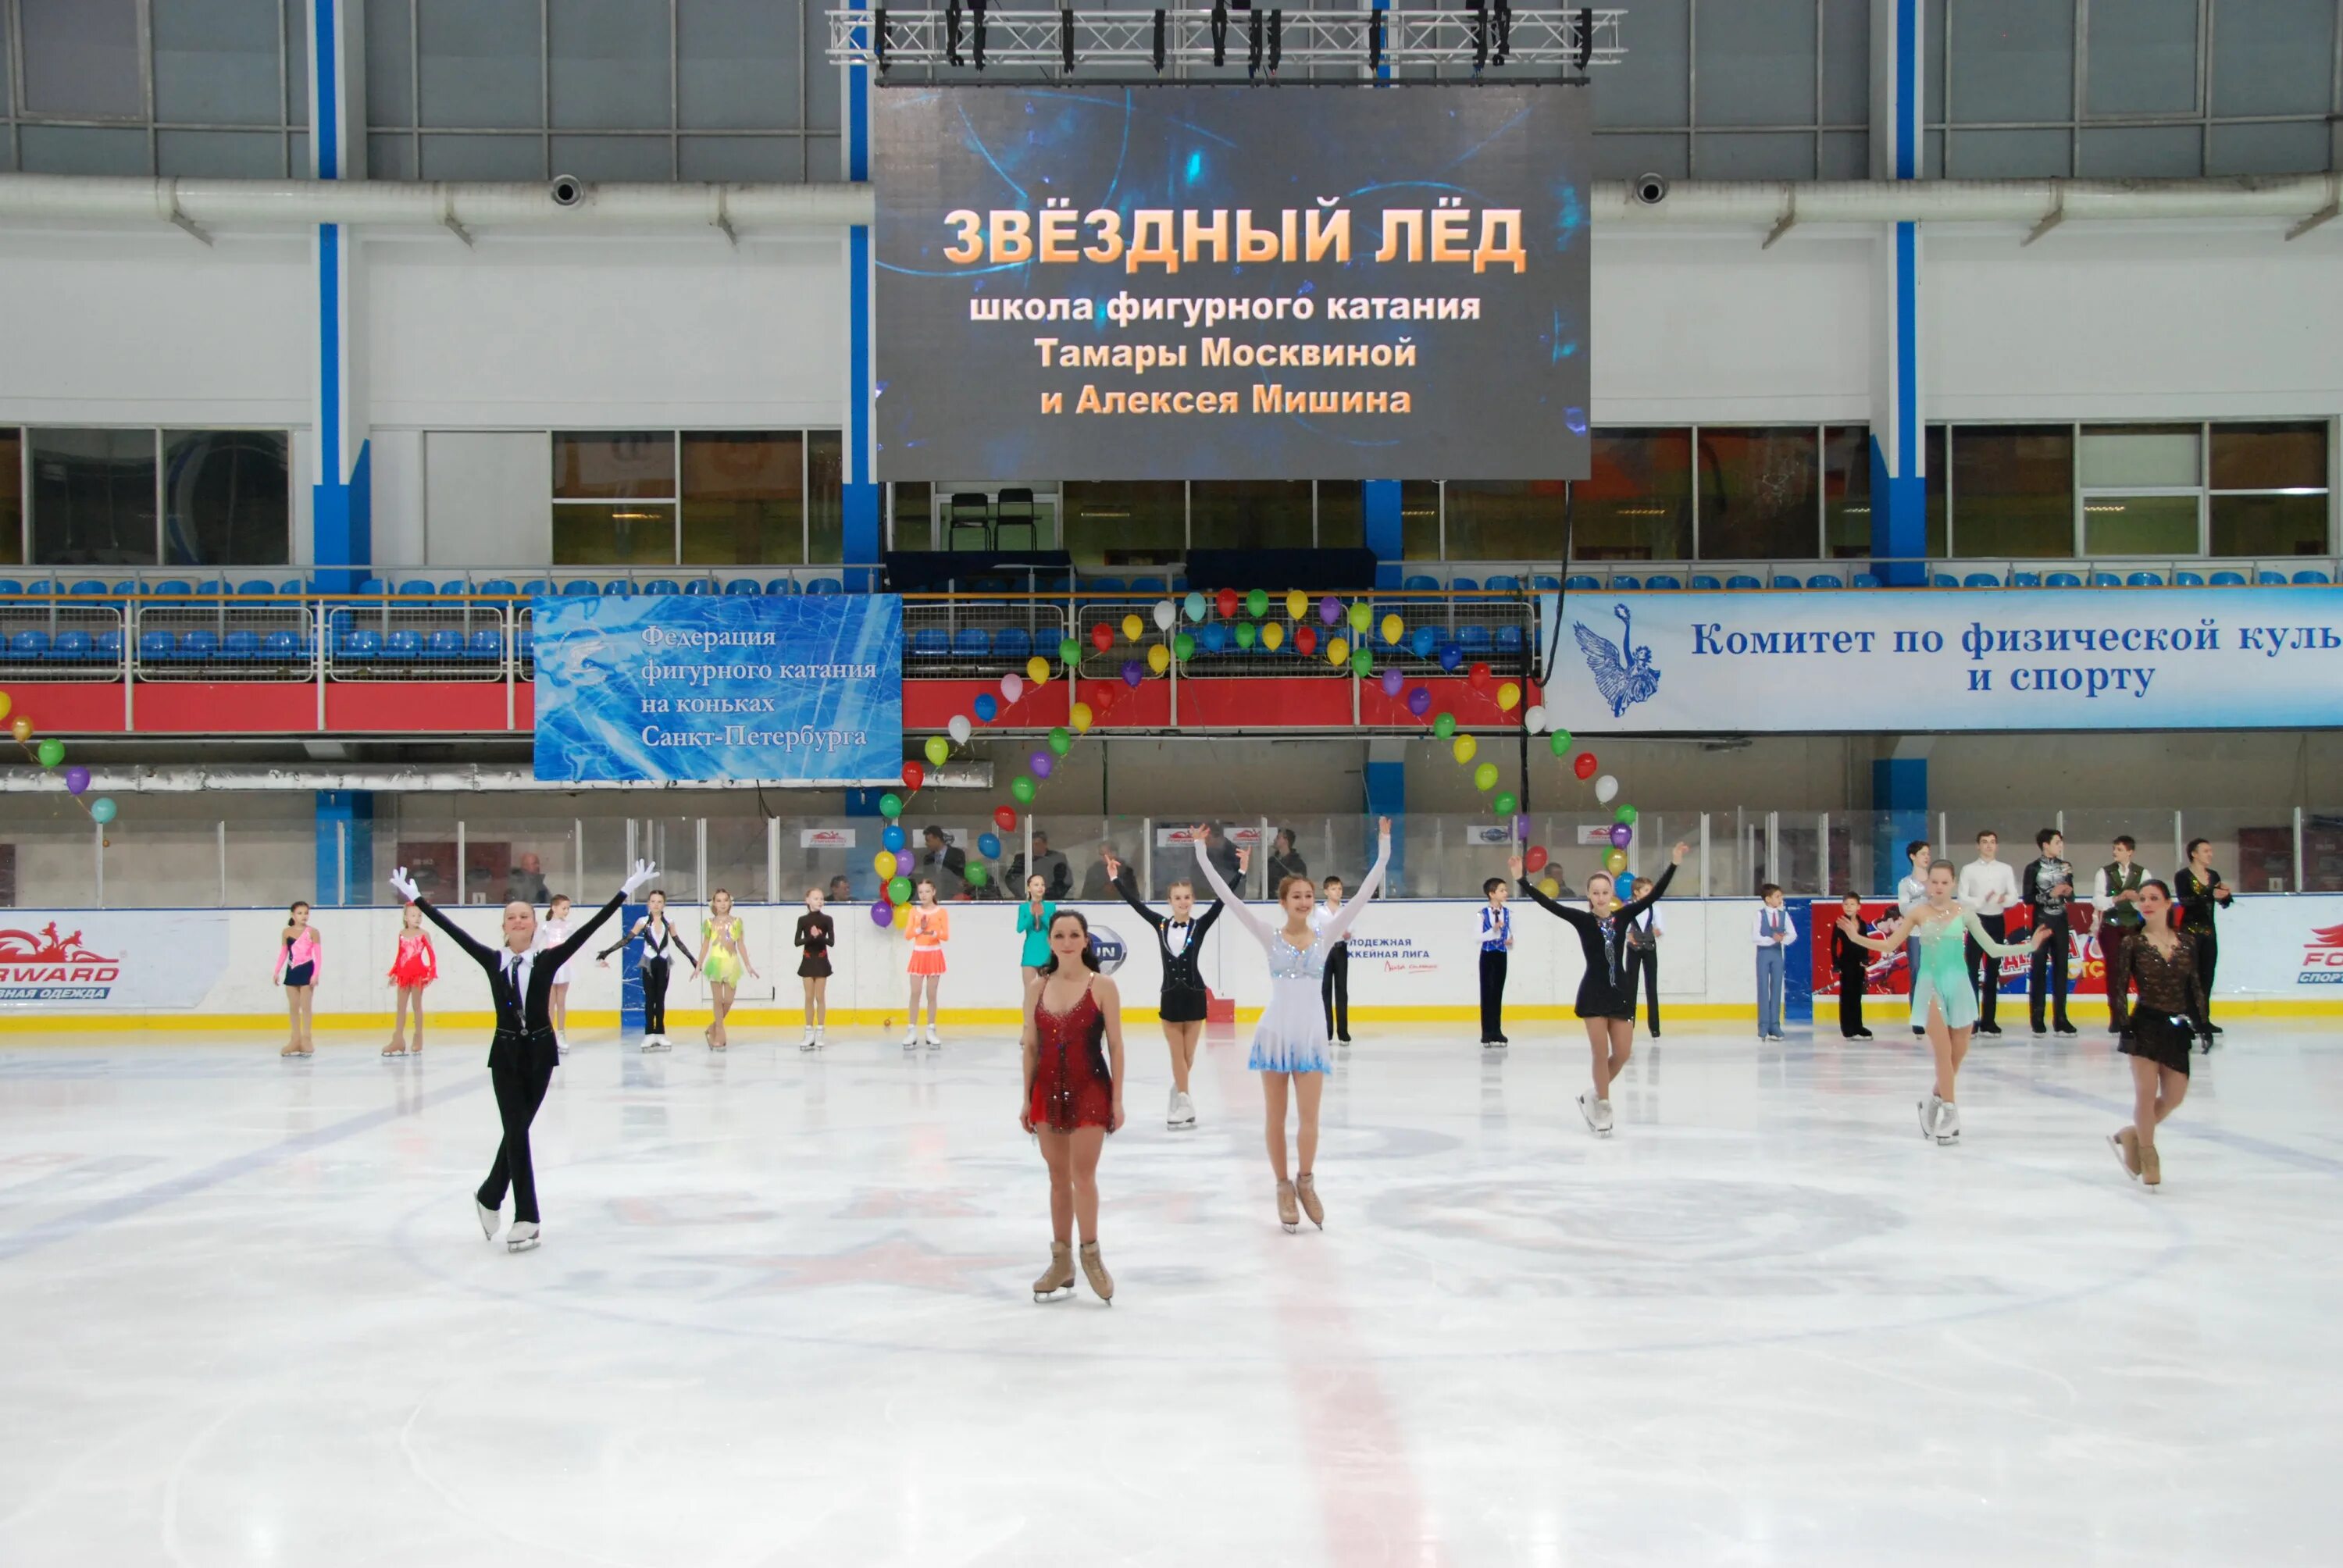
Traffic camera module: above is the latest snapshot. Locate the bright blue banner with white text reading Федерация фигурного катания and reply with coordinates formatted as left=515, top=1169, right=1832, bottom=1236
left=532, top=593, right=902, bottom=786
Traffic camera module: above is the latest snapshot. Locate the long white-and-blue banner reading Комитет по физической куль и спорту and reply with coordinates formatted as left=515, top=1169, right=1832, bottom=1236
left=1539, top=586, right=2343, bottom=733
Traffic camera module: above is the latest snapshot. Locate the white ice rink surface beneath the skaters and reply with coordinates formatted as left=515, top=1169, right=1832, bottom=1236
left=0, top=1022, right=2343, bottom=1568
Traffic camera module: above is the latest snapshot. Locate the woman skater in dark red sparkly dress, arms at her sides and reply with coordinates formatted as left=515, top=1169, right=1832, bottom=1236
left=1017, top=910, right=1122, bottom=1306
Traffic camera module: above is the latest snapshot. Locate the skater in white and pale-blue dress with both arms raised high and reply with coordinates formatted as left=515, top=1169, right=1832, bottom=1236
left=1195, top=818, right=1392, bottom=1233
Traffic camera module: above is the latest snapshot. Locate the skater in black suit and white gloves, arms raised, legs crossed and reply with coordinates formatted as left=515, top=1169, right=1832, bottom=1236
left=391, top=861, right=658, bottom=1252
